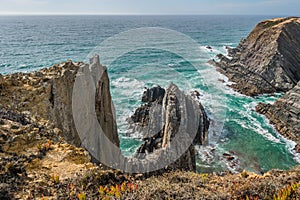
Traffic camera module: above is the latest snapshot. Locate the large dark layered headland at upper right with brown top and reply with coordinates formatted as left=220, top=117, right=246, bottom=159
left=210, top=17, right=300, bottom=96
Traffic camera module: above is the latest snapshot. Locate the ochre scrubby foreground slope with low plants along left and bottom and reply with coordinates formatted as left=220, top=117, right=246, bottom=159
left=0, top=61, right=300, bottom=199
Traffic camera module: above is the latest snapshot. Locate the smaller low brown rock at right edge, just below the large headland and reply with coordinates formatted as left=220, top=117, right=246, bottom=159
left=256, top=82, right=300, bottom=153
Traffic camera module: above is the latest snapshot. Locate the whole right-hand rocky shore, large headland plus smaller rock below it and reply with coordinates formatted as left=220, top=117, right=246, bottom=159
left=209, top=17, right=300, bottom=153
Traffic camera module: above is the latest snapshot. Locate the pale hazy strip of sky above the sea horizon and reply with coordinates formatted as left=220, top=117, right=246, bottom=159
left=0, top=0, right=300, bottom=15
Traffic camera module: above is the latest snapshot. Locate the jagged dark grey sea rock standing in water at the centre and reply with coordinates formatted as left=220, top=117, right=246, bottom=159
left=131, top=84, right=209, bottom=171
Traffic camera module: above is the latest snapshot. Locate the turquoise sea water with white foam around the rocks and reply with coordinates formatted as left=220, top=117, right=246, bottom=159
left=0, top=16, right=300, bottom=172
